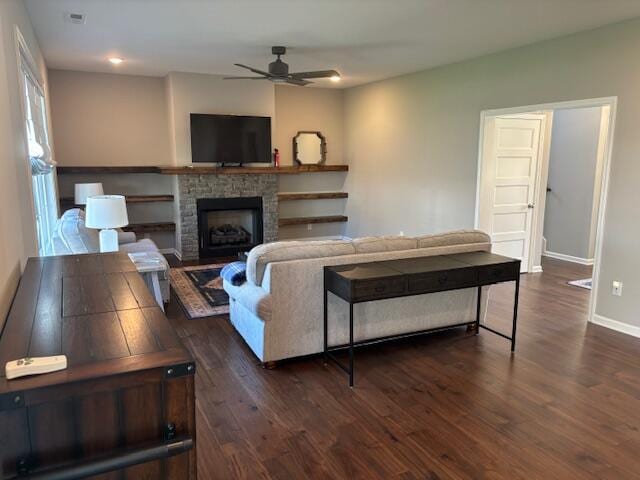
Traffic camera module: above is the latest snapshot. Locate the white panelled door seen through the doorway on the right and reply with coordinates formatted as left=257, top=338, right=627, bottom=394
left=478, top=114, right=546, bottom=272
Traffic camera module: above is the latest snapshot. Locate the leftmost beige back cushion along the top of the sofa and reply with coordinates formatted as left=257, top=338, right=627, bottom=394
left=247, top=240, right=355, bottom=285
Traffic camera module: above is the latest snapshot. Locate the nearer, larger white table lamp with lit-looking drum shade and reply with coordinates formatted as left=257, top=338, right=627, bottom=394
left=84, top=195, right=129, bottom=253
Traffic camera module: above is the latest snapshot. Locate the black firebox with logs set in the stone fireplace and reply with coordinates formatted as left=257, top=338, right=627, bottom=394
left=196, top=197, right=263, bottom=258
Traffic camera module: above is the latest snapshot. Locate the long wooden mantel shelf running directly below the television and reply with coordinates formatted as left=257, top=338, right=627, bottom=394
left=57, top=165, right=349, bottom=175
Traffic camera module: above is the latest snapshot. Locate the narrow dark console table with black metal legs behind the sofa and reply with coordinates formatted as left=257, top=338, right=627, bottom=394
left=324, top=252, right=520, bottom=386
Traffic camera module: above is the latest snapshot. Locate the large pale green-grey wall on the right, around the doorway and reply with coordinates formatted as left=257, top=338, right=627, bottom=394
left=345, top=15, right=640, bottom=326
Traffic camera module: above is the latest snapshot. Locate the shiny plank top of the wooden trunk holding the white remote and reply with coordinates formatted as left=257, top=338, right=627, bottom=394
left=0, top=253, right=193, bottom=394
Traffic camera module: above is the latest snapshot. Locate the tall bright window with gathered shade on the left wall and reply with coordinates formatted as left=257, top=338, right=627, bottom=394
left=17, top=32, right=58, bottom=256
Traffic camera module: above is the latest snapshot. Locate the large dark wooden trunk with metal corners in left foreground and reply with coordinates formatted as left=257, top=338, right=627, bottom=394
left=0, top=253, right=196, bottom=480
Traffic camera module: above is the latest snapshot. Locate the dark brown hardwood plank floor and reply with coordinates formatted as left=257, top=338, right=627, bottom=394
left=168, top=260, right=640, bottom=480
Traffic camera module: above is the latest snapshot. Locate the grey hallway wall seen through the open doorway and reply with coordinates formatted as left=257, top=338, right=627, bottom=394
left=543, top=107, right=602, bottom=260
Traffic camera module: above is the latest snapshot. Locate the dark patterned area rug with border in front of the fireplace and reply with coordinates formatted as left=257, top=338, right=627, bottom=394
left=171, top=263, right=229, bottom=319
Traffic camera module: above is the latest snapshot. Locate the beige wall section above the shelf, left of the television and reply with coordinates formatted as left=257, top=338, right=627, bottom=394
left=49, top=70, right=171, bottom=166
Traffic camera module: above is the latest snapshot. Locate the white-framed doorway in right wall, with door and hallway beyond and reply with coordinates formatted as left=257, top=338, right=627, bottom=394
left=475, top=97, right=617, bottom=321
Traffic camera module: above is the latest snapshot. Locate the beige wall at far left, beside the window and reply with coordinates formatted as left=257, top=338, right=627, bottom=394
left=0, top=0, right=48, bottom=328
